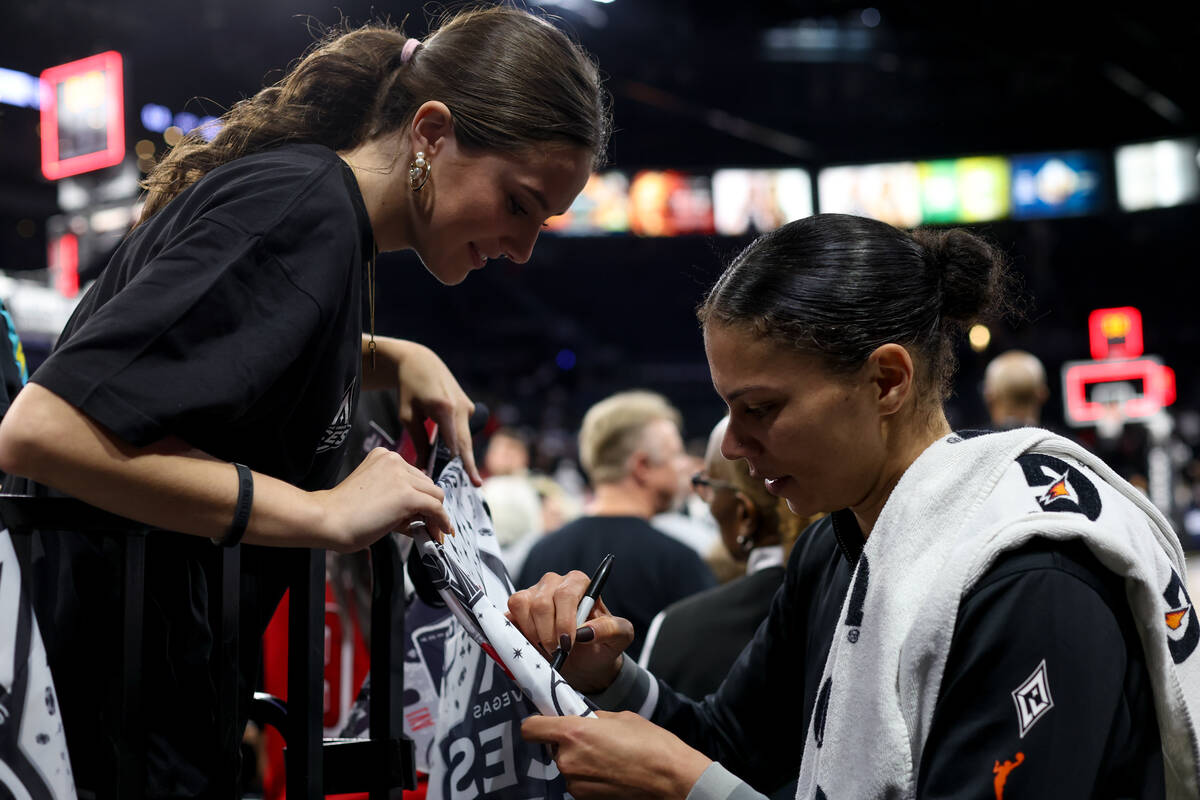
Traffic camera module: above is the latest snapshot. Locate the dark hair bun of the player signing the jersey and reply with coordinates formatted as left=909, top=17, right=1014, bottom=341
left=912, top=228, right=1008, bottom=325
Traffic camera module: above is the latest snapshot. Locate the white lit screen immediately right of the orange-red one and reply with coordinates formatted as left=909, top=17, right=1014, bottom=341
left=713, top=169, right=812, bottom=236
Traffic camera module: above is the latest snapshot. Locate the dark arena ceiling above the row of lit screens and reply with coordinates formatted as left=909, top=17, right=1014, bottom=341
left=0, top=0, right=1200, bottom=189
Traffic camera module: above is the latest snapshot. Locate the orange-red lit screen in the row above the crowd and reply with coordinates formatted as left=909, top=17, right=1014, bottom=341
left=629, top=170, right=715, bottom=236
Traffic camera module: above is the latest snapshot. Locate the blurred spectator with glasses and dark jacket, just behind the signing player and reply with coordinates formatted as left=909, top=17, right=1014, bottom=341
left=640, top=417, right=816, bottom=699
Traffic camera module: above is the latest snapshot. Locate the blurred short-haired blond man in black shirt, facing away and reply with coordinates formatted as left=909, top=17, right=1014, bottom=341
left=517, top=391, right=716, bottom=658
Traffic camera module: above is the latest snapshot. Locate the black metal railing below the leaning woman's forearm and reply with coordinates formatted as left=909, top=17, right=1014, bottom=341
left=0, top=494, right=416, bottom=800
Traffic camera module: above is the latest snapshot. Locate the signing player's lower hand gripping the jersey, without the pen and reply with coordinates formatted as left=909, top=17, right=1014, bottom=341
left=521, top=711, right=712, bottom=800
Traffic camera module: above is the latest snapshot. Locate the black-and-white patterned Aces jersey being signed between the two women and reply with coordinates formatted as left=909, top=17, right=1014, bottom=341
left=406, top=459, right=592, bottom=800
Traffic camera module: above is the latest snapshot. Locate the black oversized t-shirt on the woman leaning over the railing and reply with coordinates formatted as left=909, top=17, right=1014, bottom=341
left=31, top=145, right=373, bottom=489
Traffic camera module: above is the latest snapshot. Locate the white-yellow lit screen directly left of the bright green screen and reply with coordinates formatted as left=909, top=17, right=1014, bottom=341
left=817, top=162, right=922, bottom=228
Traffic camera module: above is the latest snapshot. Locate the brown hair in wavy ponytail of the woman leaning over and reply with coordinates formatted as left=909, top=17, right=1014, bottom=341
left=139, top=6, right=612, bottom=223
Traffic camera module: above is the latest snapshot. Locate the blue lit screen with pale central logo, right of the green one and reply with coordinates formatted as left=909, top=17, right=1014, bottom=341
left=1012, top=150, right=1104, bottom=219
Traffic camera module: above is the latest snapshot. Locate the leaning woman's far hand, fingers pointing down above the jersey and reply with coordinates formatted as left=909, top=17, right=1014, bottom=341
left=362, top=336, right=484, bottom=486
